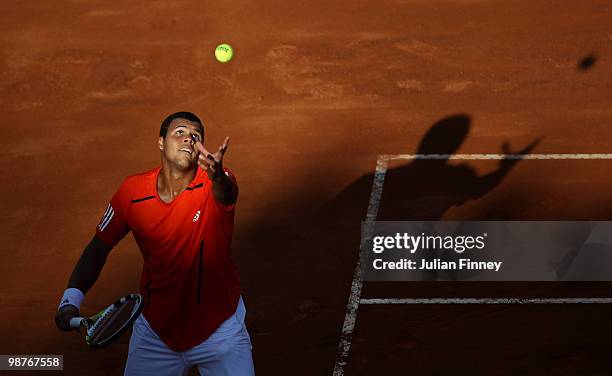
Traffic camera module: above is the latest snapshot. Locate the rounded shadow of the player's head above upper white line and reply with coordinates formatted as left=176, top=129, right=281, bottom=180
left=417, top=114, right=471, bottom=155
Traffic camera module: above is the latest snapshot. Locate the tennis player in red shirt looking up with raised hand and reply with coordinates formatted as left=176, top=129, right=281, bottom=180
left=55, top=112, right=254, bottom=376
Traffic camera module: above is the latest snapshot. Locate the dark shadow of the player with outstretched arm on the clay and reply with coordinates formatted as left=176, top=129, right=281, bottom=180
left=323, top=114, right=540, bottom=280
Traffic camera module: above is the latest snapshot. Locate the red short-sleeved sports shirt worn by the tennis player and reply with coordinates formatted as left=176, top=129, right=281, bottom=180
left=96, top=167, right=240, bottom=351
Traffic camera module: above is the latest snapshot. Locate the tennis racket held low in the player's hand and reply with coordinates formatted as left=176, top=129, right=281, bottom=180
left=70, top=294, right=143, bottom=349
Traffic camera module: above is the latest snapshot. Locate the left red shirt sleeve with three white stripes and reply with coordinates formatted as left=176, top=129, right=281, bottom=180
left=96, top=180, right=130, bottom=247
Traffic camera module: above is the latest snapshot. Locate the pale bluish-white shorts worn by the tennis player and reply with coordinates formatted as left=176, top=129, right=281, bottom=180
left=124, top=297, right=255, bottom=376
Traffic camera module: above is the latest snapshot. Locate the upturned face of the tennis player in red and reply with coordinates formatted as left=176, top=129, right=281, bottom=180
left=159, top=119, right=203, bottom=169
